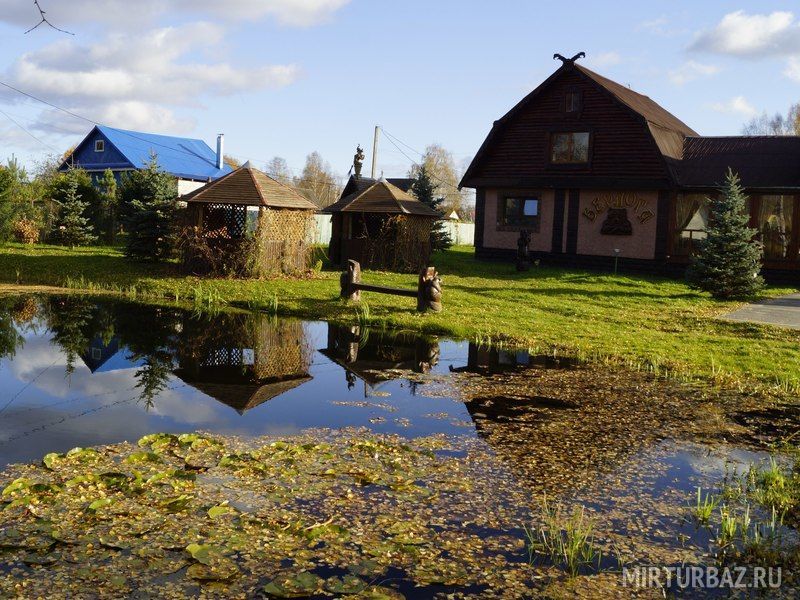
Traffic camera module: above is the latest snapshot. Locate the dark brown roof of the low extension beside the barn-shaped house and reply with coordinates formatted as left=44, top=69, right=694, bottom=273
left=677, top=136, right=800, bottom=189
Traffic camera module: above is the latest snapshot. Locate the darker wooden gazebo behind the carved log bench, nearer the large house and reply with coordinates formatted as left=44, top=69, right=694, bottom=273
left=322, top=179, right=442, bottom=273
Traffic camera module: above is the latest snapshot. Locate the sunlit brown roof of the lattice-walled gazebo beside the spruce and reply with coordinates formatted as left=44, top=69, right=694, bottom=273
left=181, top=164, right=317, bottom=211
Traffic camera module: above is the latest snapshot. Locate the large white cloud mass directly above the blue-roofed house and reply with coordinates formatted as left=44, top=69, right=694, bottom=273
left=4, top=23, right=299, bottom=133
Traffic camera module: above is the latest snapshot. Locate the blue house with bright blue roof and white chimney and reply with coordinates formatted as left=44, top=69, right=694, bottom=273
left=59, top=125, right=231, bottom=196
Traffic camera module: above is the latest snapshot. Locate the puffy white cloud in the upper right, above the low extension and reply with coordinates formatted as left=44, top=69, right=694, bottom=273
left=691, top=10, right=800, bottom=58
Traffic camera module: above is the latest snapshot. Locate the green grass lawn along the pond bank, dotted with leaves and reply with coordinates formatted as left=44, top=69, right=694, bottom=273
left=0, top=244, right=800, bottom=386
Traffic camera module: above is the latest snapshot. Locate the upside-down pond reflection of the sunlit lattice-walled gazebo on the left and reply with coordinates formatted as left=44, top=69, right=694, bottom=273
left=175, top=314, right=311, bottom=414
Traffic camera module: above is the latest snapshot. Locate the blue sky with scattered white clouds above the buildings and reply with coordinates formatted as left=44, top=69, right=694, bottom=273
left=0, top=0, right=800, bottom=176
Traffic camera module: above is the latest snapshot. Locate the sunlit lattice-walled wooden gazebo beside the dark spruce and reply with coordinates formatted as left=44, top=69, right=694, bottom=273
left=182, top=162, right=317, bottom=277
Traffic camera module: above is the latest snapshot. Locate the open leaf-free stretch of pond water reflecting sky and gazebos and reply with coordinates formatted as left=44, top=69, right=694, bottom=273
left=0, top=295, right=471, bottom=464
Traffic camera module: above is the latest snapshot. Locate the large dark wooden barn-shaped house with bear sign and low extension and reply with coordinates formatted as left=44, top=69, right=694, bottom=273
left=461, top=55, right=800, bottom=279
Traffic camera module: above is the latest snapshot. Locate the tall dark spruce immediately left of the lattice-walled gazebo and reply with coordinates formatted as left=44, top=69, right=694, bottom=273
left=120, top=156, right=178, bottom=261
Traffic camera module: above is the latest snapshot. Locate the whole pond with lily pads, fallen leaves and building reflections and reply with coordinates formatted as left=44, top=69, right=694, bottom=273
left=0, top=295, right=800, bottom=598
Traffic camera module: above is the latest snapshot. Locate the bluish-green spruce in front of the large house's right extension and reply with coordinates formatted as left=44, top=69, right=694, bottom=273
left=687, top=169, right=764, bottom=298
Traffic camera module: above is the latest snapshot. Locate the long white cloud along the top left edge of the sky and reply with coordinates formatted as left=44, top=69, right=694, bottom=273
left=0, top=0, right=350, bottom=30
